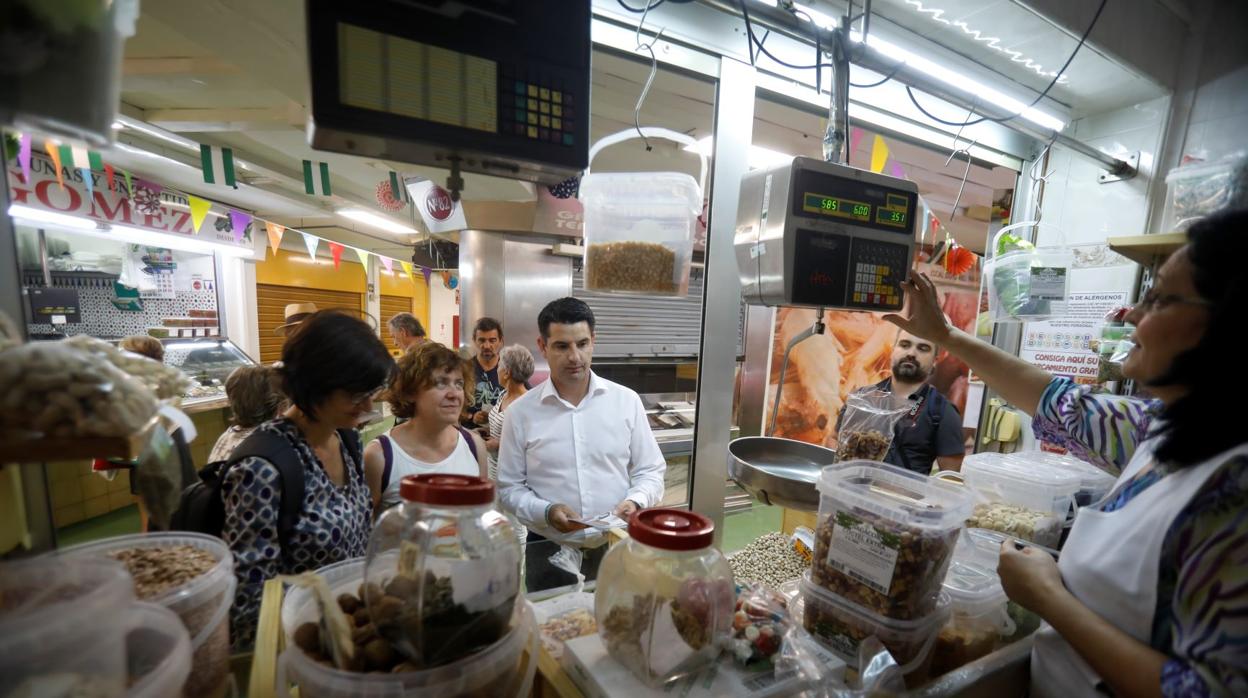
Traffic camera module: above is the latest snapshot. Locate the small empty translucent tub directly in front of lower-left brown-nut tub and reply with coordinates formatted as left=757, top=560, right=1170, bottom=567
left=125, top=603, right=191, bottom=698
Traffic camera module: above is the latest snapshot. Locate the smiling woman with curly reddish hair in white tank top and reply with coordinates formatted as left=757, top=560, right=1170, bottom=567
left=364, top=342, right=487, bottom=514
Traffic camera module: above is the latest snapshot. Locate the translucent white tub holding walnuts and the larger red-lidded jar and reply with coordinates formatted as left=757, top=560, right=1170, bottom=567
left=277, top=558, right=540, bottom=698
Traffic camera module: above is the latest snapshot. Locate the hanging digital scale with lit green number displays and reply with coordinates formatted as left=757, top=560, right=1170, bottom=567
left=734, top=157, right=919, bottom=311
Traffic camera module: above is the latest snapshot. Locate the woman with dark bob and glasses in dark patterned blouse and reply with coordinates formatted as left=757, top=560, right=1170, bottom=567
left=221, top=310, right=394, bottom=649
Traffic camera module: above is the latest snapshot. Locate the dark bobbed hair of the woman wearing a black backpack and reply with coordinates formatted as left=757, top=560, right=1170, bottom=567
left=281, top=310, right=394, bottom=420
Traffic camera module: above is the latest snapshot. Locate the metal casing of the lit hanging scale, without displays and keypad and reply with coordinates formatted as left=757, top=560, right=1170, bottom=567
left=733, top=157, right=919, bottom=310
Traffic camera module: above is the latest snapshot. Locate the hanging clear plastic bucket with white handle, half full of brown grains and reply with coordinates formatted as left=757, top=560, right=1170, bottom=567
left=580, top=129, right=706, bottom=296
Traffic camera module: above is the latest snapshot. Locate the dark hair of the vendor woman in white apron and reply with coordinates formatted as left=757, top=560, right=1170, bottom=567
left=1152, top=209, right=1248, bottom=467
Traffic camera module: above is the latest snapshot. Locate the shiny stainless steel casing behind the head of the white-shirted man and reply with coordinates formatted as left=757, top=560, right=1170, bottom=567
left=459, top=230, right=572, bottom=362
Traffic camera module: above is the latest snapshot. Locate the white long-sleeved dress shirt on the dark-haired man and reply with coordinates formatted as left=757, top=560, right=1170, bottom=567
left=498, top=371, right=668, bottom=544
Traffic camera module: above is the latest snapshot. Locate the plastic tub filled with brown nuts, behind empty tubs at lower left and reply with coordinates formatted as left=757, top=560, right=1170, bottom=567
left=56, top=532, right=236, bottom=698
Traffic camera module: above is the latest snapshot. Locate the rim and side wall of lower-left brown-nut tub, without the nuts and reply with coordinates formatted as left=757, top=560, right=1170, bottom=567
left=57, top=532, right=236, bottom=698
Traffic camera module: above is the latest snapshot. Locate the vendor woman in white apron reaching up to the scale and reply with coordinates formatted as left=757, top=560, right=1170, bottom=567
left=887, top=210, right=1248, bottom=698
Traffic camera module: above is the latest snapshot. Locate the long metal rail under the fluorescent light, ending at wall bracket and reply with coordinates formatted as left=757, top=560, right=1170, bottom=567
left=701, top=0, right=1136, bottom=179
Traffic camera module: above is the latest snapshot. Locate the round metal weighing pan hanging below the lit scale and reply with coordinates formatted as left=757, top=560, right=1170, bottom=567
left=728, top=436, right=836, bottom=512
